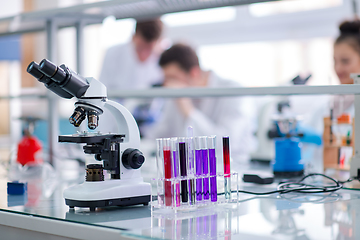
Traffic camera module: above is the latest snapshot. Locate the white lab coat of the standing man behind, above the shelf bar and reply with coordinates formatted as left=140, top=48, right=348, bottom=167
left=99, top=42, right=163, bottom=89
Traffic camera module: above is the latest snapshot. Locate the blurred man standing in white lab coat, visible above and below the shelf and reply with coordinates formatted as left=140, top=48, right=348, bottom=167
left=99, top=18, right=163, bottom=132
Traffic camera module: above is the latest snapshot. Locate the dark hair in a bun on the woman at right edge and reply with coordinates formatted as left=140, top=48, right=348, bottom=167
left=335, top=20, right=360, bottom=54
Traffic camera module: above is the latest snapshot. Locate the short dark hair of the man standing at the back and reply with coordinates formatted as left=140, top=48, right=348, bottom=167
left=135, top=18, right=163, bottom=42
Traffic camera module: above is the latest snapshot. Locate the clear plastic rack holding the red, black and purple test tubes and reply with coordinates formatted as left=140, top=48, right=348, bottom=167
left=151, top=172, right=239, bottom=212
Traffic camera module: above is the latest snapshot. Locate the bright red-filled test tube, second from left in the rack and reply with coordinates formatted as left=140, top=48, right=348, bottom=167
left=163, top=138, right=173, bottom=207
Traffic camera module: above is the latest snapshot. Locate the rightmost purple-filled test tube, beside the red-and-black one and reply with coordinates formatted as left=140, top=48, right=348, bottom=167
left=208, top=136, right=217, bottom=202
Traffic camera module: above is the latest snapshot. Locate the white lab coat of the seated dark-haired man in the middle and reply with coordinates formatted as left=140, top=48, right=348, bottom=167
left=146, top=72, right=254, bottom=159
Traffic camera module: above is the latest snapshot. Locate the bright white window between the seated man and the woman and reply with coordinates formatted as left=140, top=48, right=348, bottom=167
left=198, top=38, right=338, bottom=87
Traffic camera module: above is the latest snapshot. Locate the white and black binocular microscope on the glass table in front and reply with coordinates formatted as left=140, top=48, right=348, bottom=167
left=27, top=59, right=151, bottom=211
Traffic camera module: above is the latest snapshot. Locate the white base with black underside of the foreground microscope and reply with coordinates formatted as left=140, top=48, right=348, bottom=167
left=64, top=178, right=151, bottom=211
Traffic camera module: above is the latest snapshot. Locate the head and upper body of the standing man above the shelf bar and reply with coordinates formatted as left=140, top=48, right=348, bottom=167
left=99, top=19, right=163, bottom=89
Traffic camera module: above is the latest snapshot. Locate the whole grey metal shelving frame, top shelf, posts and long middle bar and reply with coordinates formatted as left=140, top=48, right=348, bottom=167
left=0, top=0, right=360, bottom=177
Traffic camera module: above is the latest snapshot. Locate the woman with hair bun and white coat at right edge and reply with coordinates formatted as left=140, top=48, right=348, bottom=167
left=290, top=20, right=360, bottom=132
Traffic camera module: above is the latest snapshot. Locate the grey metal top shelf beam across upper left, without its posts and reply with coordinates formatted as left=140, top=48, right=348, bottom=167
left=0, top=0, right=277, bottom=36
